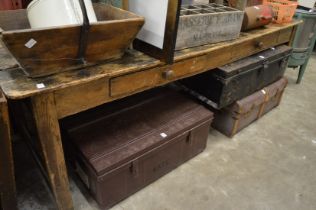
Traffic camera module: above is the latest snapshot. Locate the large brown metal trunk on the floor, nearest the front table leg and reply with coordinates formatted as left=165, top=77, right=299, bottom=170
left=62, top=89, right=213, bottom=208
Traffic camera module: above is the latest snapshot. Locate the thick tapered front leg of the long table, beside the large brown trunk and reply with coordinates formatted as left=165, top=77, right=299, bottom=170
left=32, top=93, right=73, bottom=210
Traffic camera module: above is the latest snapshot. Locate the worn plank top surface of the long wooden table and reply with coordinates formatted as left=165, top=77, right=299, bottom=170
left=0, top=22, right=300, bottom=99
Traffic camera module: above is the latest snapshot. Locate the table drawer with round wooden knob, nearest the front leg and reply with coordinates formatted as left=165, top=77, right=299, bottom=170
left=110, top=47, right=231, bottom=98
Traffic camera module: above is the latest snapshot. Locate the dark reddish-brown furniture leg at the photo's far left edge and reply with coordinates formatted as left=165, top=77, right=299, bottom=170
left=0, top=91, right=17, bottom=210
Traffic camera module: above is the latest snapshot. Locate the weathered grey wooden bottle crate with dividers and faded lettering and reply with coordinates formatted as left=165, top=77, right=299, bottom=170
left=176, top=3, right=244, bottom=50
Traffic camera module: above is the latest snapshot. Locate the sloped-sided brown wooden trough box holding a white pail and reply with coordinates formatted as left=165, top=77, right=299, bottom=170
left=0, top=4, right=144, bottom=77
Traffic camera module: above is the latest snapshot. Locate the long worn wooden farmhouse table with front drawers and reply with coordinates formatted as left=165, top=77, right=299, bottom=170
left=0, top=22, right=299, bottom=210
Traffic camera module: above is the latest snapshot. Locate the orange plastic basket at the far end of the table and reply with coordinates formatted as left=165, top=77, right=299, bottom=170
left=262, top=0, right=298, bottom=23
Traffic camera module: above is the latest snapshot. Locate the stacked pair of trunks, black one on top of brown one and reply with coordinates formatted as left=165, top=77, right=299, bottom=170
left=182, top=45, right=292, bottom=137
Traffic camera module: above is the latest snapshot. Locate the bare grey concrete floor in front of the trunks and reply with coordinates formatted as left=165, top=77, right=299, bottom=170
left=16, top=55, right=316, bottom=210
